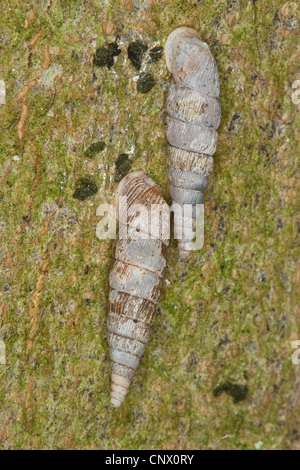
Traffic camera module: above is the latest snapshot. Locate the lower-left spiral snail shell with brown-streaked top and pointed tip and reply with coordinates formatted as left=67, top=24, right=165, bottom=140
left=107, top=171, right=170, bottom=407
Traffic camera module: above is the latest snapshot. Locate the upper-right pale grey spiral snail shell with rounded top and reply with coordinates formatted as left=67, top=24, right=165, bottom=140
left=165, top=28, right=221, bottom=257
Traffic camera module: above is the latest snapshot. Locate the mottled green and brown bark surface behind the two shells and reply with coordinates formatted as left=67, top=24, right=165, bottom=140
left=0, top=0, right=300, bottom=449
